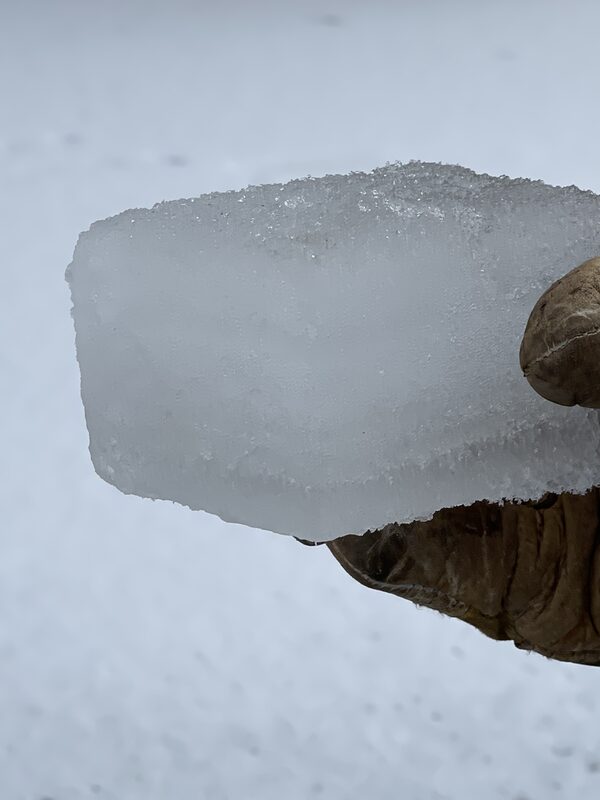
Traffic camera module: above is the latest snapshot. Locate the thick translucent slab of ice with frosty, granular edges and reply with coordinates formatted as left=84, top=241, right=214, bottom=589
left=68, top=163, right=600, bottom=540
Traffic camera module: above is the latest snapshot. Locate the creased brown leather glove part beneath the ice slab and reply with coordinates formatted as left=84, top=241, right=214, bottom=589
left=327, top=489, right=600, bottom=665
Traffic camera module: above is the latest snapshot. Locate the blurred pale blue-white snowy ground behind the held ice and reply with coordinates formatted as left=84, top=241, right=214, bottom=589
left=0, top=0, right=600, bottom=800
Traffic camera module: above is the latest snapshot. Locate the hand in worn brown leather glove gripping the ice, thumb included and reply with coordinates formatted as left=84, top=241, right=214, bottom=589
left=327, top=259, right=600, bottom=666
